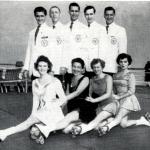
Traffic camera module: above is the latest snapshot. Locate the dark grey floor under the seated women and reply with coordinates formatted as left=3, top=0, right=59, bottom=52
left=0, top=86, right=150, bottom=150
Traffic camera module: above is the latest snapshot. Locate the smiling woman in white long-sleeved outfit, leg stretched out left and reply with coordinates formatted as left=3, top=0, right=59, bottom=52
left=0, top=56, right=66, bottom=141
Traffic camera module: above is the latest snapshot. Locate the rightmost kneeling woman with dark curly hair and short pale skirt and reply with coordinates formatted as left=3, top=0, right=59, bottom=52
left=100, top=53, right=150, bottom=134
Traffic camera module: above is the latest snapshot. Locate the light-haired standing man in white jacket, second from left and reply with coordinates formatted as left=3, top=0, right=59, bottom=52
left=49, top=6, right=66, bottom=75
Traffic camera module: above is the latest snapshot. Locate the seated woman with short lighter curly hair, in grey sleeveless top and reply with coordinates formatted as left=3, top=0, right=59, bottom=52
left=69, top=59, right=118, bottom=134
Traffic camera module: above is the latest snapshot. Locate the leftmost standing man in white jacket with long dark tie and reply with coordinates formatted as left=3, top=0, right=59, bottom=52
left=20, top=7, right=52, bottom=80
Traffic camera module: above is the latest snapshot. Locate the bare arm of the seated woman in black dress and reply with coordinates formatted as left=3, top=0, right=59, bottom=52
left=67, top=77, right=89, bottom=100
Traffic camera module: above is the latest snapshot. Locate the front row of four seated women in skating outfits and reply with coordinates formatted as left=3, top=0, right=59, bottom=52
left=0, top=53, right=150, bottom=144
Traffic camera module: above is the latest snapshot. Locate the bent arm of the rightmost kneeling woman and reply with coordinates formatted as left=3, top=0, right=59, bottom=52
left=118, top=74, right=136, bottom=99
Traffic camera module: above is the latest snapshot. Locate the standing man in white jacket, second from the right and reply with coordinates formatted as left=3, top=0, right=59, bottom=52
left=84, top=6, right=105, bottom=71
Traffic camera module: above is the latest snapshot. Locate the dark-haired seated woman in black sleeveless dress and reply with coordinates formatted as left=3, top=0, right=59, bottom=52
left=31, top=58, right=89, bottom=142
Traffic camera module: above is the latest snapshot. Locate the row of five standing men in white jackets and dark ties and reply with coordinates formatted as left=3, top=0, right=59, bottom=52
left=20, top=3, right=127, bottom=79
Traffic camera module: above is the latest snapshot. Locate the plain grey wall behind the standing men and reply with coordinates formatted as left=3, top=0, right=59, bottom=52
left=0, top=1, right=150, bottom=68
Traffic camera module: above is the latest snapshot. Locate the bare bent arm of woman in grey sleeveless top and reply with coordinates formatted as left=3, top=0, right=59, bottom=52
left=87, top=76, right=113, bottom=103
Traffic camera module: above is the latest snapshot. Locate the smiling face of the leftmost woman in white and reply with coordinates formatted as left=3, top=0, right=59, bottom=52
left=37, top=61, right=49, bottom=75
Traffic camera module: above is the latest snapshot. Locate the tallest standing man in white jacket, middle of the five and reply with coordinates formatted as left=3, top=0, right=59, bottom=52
left=64, top=3, right=86, bottom=71
